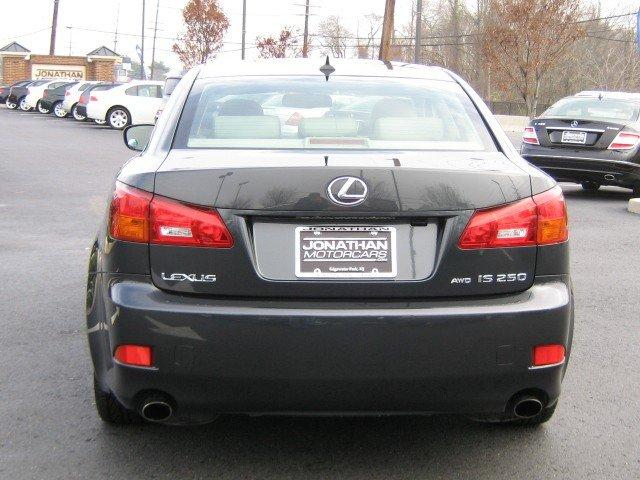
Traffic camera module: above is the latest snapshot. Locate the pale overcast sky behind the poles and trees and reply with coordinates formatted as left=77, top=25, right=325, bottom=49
left=0, top=0, right=637, bottom=73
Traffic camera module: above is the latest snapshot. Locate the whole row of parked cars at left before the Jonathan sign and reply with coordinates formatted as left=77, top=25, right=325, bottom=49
left=0, top=77, right=165, bottom=130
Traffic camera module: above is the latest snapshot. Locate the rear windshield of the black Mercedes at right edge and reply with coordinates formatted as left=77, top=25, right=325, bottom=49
left=542, top=98, right=640, bottom=122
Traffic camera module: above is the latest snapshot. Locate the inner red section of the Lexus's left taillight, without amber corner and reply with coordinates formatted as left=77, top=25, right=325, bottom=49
left=150, top=197, right=233, bottom=248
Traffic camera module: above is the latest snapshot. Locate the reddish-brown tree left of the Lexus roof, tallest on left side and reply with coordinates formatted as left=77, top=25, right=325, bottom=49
left=173, top=0, right=229, bottom=68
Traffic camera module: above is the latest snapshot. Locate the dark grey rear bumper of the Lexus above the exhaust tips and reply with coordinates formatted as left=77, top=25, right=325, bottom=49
left=88, top=275, right=573, bottom=423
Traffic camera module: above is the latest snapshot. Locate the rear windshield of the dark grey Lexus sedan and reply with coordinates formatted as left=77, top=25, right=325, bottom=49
left=174, top=76, right=495, bottom=151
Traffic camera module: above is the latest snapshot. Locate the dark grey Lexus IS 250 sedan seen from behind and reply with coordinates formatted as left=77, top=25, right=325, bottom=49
left=86, top=59, right=573, bottom=425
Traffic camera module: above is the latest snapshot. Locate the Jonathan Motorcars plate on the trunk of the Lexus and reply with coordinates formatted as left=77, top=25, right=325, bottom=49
left=295, top=226, right=397, bottom=279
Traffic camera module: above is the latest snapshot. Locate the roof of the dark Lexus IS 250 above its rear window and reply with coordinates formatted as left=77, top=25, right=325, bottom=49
left=199, top=58, right=453, bottom=81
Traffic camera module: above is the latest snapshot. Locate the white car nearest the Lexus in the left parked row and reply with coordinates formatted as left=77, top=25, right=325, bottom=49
left=87, top=80, right=163, bottom=130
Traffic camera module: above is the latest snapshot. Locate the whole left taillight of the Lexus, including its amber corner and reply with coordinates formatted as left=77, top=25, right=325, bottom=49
left=109, top=182, right=233, bottom=248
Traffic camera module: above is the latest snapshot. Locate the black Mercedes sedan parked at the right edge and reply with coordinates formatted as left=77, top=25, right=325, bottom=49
left=521, top=92, right=640, bottom=196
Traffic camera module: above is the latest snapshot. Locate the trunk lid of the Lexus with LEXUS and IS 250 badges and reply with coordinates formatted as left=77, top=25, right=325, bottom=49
left=150, top=150, right=536, bottom=299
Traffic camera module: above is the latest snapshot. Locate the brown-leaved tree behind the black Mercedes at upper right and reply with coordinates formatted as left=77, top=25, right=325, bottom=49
left=481, top=0, right=586, bottom=116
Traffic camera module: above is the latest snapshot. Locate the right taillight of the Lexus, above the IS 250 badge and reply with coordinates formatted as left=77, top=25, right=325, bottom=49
left=458, top=186, right=569, bottom=250
